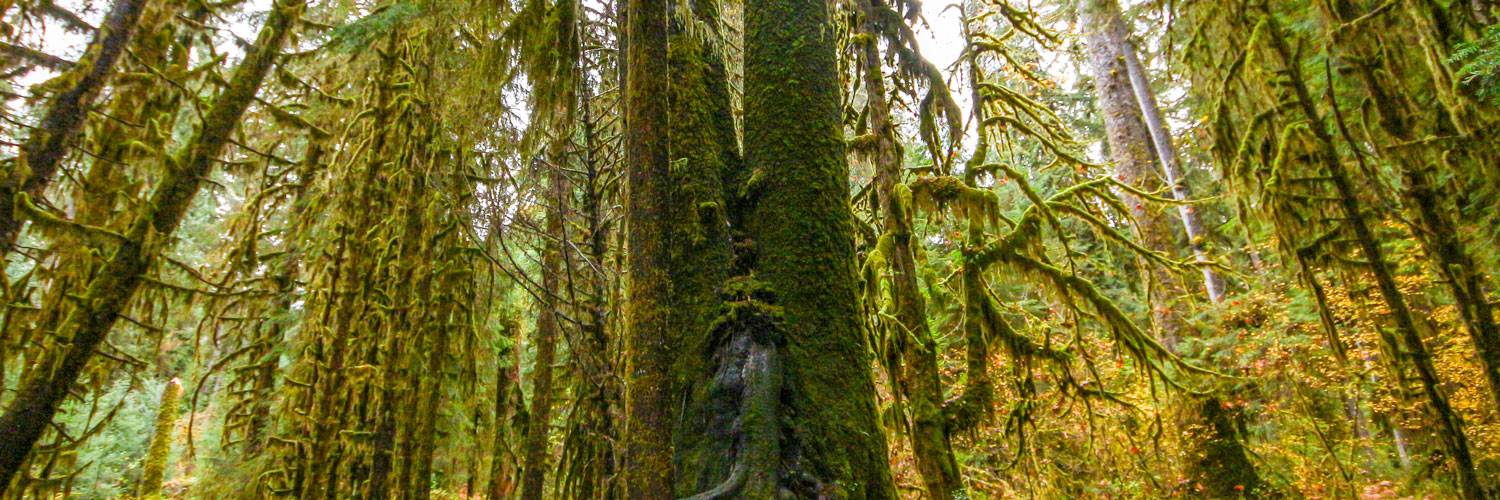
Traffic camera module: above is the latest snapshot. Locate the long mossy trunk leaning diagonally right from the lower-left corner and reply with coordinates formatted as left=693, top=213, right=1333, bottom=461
left=0, top=0, right=305, bottom=492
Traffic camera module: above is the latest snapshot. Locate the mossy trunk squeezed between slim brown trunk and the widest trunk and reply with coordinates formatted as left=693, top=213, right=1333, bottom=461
left=666, top=0, right=743, bottom=489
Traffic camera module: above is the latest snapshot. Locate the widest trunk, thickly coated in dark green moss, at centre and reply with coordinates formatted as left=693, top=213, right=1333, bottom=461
left=744, top=0, right=896, bottom=489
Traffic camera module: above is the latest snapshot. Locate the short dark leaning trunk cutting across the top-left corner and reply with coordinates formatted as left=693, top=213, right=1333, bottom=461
left=0, top=0, right=149, bottom=252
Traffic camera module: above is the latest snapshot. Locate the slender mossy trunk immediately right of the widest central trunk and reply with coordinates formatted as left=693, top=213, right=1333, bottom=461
left=860, top=0, right=963, bottom=498
